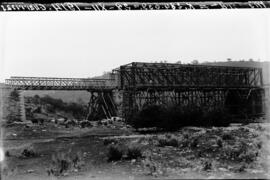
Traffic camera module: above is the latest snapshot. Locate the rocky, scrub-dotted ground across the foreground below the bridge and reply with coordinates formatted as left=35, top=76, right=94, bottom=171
left=2, top=122, right=270, bottom=179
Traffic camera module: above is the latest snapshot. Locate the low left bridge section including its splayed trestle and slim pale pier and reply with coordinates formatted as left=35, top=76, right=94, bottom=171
left=5, top=76, right=117, bottom=119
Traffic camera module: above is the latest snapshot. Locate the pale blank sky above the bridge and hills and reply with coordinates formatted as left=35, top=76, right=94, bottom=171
left=0, top=9, right=270, bottom=82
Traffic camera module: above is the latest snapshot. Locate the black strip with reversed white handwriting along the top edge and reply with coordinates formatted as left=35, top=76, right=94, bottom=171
left=0, top=1, right=270, bottom=11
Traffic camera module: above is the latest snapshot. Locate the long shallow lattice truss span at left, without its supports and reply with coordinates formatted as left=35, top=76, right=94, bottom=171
left=5, top=76, right=115, bottom=91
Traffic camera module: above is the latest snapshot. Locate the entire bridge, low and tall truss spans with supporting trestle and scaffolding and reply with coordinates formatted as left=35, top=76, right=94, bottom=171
left=5, top=62, right=265, bottom=120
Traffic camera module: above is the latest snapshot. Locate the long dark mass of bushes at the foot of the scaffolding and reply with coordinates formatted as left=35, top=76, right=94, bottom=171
left=129, top=105, right=231, bottom=131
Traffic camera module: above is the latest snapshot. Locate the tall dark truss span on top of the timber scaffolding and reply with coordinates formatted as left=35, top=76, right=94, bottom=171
left=118, top=62, right=262, bottom=89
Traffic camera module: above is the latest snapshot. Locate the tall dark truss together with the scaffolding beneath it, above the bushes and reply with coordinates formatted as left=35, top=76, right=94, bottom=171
left=115, top=62, right=264, bottom=119
